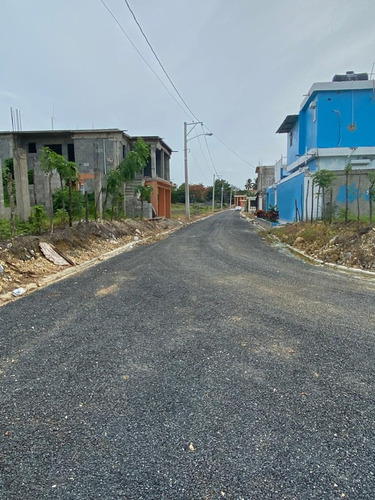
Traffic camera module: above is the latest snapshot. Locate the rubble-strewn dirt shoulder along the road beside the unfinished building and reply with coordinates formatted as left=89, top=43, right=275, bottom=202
left=0, top=219, right=191, bottom=305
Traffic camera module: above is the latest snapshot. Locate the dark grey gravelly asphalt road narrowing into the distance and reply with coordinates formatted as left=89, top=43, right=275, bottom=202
left=0, top=212, right=375, bottom=500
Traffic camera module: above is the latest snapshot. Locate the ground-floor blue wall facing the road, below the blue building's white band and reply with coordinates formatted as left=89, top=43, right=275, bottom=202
left=277, top=172, right=305, bottom=222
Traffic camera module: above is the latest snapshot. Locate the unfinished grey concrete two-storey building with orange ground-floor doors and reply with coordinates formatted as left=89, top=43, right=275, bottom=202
left=0, top=129, right=172, bottom=217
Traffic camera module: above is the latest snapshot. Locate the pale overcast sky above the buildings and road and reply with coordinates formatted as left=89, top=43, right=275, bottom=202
left=0, top=0, right=375, bottom=189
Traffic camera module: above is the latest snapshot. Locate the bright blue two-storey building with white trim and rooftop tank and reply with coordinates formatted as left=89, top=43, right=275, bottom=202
left=274, top=72, right=375, bottom=221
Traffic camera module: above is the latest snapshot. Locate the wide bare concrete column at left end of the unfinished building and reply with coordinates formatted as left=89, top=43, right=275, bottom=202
left=13, top=148, right=31, bottom=221
